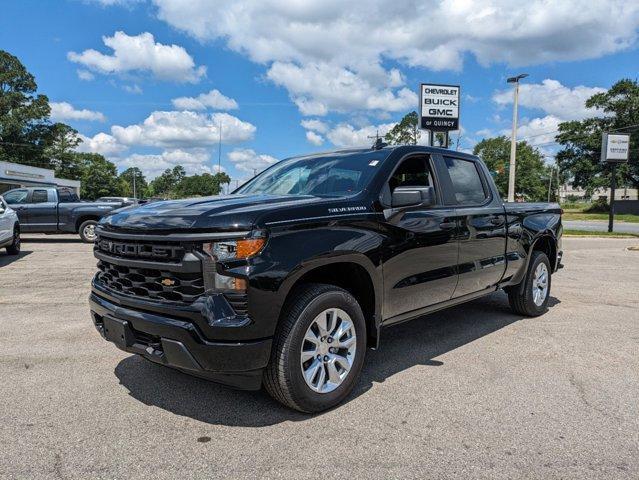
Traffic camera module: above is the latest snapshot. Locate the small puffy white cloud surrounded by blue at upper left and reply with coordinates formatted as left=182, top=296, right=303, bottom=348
left=67, top=32, right=206, bottom=83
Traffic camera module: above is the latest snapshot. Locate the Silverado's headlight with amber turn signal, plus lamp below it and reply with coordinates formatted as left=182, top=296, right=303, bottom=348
left=202, top=238, right=266, bottom=291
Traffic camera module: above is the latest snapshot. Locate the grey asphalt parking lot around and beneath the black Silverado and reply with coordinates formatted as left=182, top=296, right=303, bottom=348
left=0, top=235, right=639, bottom=479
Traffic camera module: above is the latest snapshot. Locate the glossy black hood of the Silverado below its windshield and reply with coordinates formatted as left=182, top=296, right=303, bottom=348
left=100, top=195, right=327, bottom=231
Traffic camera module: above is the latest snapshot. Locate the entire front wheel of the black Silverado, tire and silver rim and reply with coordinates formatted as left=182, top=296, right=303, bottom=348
left=264, top=284, right=366, bottom=413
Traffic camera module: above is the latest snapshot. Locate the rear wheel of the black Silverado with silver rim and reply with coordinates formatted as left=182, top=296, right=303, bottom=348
left=507, top=251, right=550, bottom=317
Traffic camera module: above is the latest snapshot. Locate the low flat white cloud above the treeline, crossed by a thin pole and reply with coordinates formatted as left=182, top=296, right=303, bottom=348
left=111, top=111, right=256, bottom=148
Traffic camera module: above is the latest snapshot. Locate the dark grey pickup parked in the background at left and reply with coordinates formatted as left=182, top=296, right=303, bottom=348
left=2, top=187, right=123, bottom=243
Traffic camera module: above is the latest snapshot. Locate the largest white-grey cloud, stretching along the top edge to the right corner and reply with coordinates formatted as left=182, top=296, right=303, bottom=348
left=154, top=0, right=639, bottom=69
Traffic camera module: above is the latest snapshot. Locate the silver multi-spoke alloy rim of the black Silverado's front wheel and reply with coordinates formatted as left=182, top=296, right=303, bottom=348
left=300, top=308, right=357, bottom=393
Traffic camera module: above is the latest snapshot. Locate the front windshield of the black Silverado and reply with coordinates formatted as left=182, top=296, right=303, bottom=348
left=234, top=150, right=388, bottom=197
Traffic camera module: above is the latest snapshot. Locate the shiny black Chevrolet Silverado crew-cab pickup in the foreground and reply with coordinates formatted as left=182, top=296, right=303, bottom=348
left=90, top=146, right=562, bottom=412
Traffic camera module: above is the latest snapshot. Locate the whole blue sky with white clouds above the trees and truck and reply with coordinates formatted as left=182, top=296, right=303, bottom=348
left=0, top=0, right=639, bottom=185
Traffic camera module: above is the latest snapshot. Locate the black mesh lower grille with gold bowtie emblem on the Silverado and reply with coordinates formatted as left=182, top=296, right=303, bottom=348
left=96, top=260, right=204, bottom=303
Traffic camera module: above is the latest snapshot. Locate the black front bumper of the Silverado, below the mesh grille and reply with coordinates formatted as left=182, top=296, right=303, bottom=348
left=89, top=288, right=271, bottom=390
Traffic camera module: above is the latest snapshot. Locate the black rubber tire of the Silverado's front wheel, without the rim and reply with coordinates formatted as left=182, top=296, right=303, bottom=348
left=264, top=284, right=366, bottom=413
